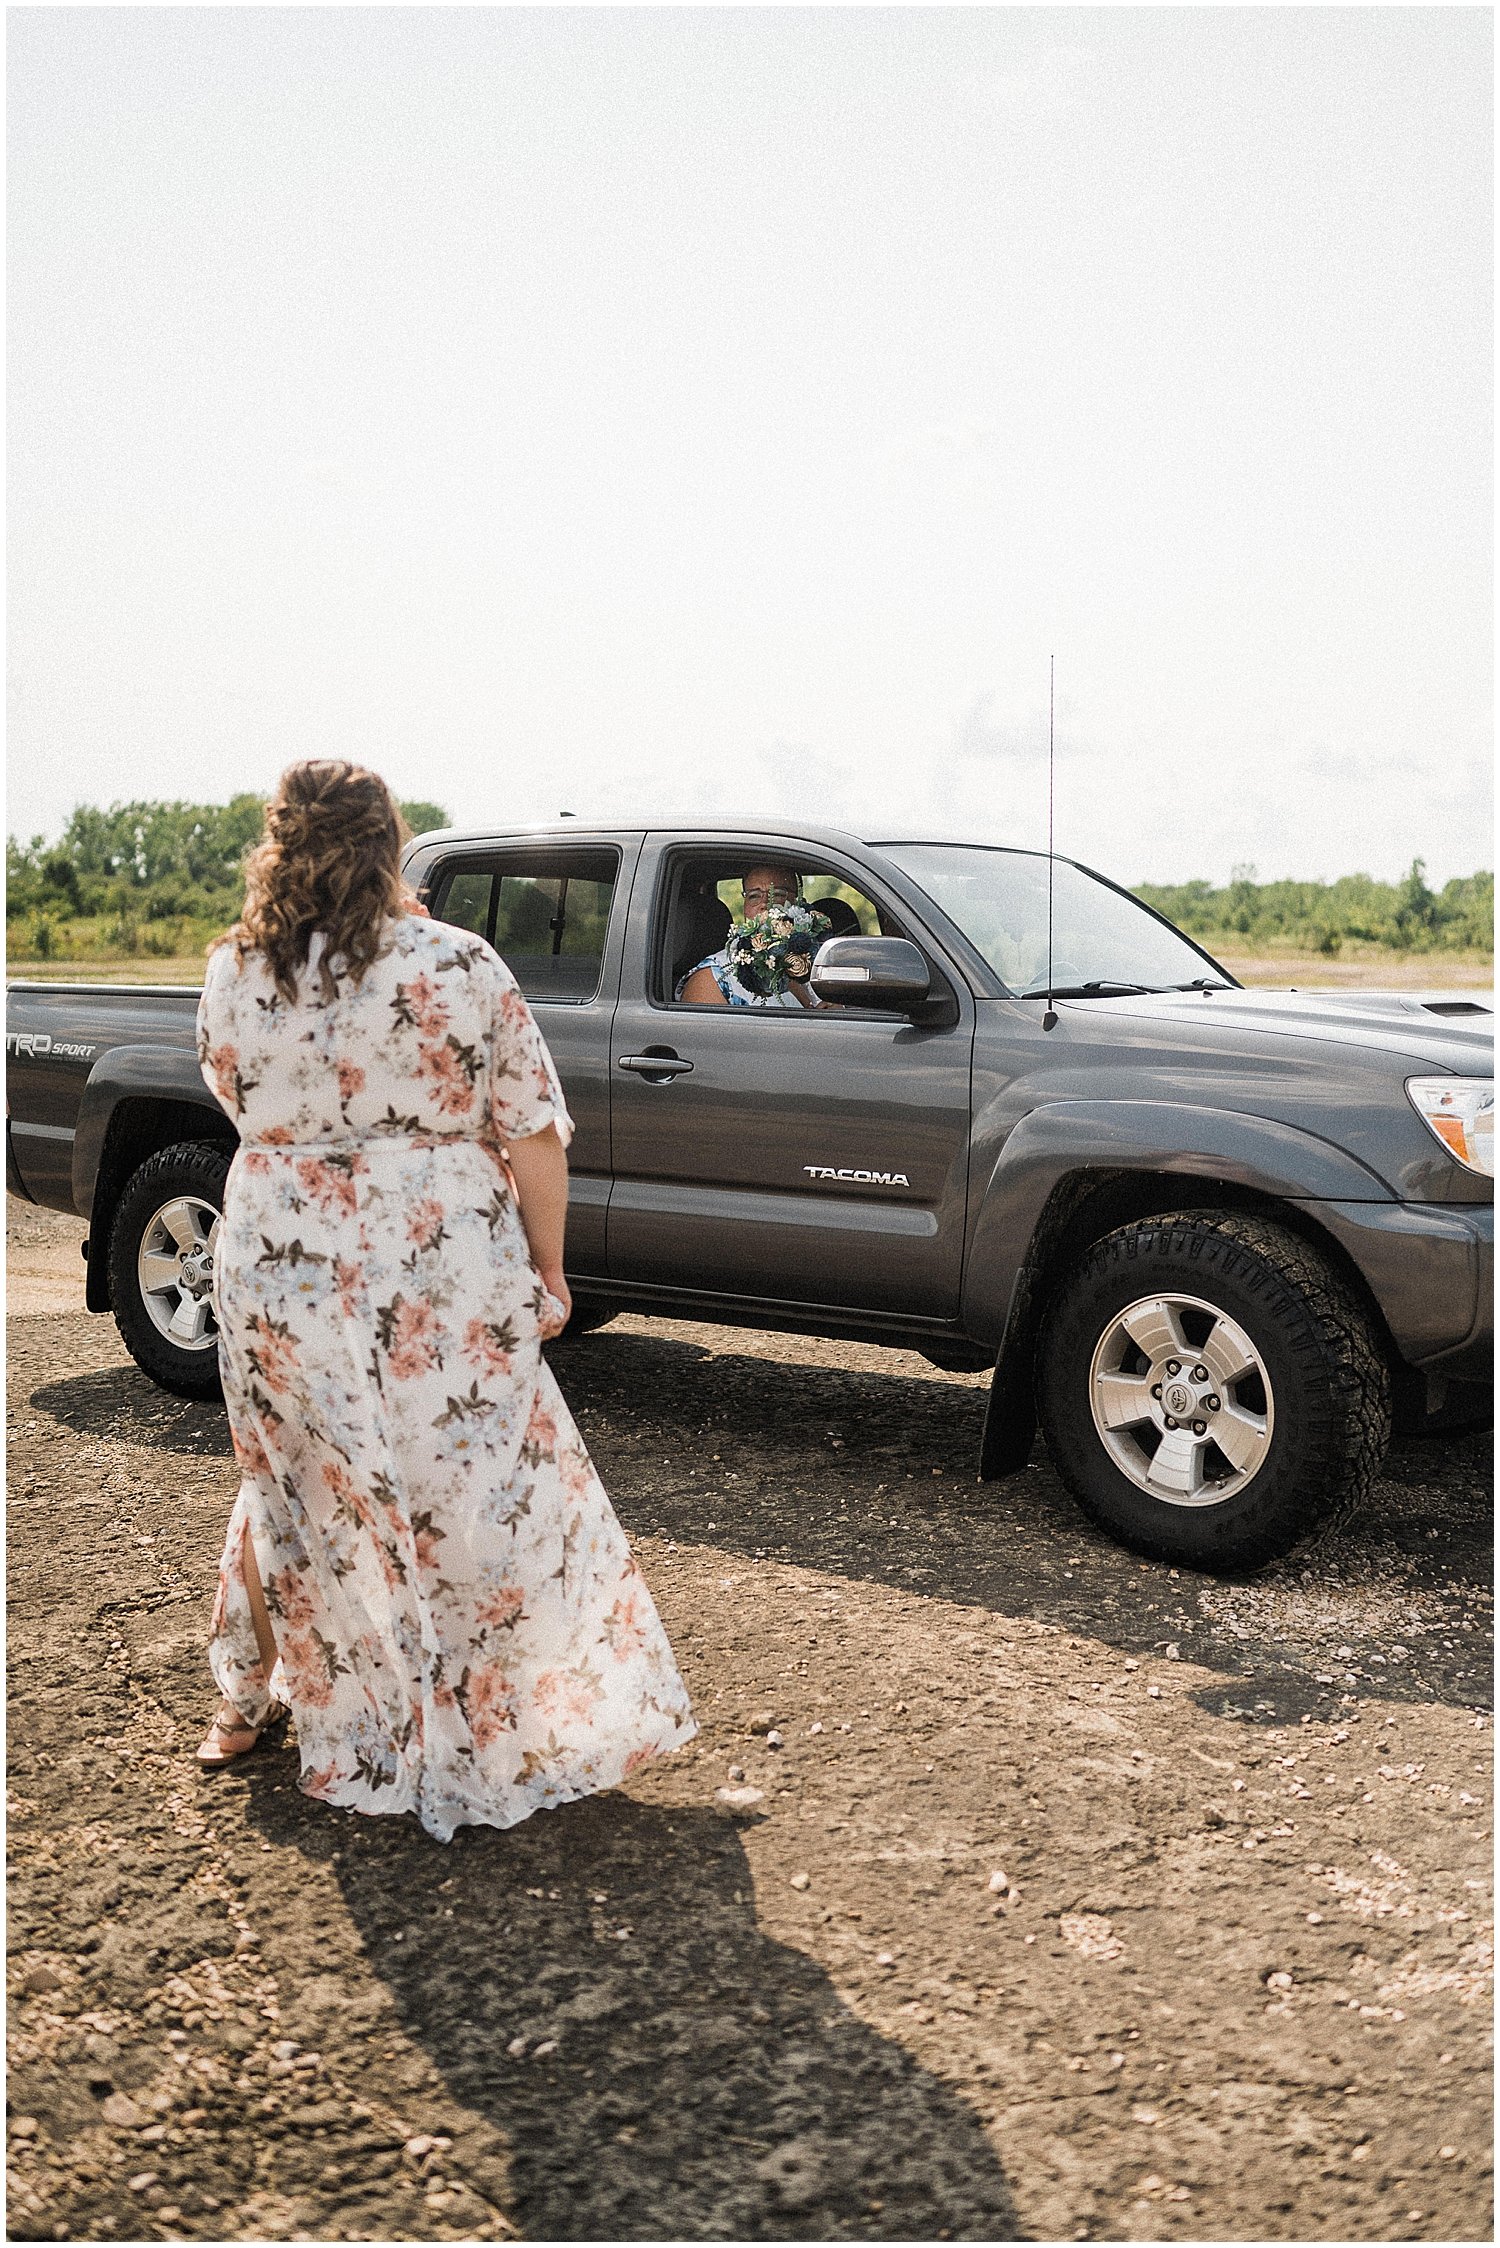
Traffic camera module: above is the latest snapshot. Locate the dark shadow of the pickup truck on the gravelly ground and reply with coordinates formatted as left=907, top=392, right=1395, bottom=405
left=31, top=1329, right=1493, bottom=1724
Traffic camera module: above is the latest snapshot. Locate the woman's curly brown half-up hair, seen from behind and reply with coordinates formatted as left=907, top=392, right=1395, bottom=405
left=220, top=758, right=414, bottom=1003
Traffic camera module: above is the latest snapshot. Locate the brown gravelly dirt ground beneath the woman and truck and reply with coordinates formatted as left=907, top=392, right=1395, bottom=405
left=9, top=1205, right=1491, bottom=2241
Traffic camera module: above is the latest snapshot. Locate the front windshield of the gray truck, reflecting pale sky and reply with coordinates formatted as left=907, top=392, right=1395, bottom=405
left=879, top=843, right=1223, bottom=994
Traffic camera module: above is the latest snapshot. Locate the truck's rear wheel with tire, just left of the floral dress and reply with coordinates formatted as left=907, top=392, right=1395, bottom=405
left=110, top=1140, right=229, bottom=1398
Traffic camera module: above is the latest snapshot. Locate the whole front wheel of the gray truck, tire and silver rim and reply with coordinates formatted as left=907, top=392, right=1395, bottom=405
left=1039, top=1212, right=1392, bottom=1571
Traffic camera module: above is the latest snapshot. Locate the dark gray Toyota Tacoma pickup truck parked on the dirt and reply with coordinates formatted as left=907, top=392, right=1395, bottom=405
left=7, top=821, right=1493, bottom=1569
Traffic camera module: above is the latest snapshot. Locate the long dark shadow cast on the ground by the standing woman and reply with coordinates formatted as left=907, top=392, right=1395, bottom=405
left=247, top=1762, right=1023, bottom=2241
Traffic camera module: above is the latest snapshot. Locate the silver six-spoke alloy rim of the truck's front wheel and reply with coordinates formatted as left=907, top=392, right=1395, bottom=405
left=1088, top=1295, right=1275, bottom=1506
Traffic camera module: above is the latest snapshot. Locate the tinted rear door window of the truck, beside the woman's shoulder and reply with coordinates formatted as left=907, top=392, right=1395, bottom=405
left=432, top=850, right=621, bottom=1005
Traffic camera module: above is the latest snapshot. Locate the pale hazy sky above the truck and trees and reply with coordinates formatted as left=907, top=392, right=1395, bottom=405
left=7, top=7, right=1491, bottom=881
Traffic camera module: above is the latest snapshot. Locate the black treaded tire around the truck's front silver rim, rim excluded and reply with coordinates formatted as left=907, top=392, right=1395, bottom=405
left=1037, top=1209, right=1392, bottom=1574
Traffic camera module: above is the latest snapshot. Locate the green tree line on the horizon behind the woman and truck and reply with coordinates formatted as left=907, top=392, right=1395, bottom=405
left=4, top=794, right=1496, bottom=960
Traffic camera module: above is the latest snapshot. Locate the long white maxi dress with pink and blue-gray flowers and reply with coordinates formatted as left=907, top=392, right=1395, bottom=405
left=198, top=917, right=697, bottom=1841
